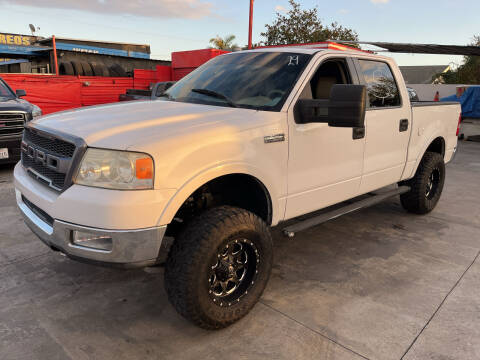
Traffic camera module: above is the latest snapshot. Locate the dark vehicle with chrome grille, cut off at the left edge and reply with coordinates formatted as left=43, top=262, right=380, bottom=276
left=0, top=78, right=42, bottom=164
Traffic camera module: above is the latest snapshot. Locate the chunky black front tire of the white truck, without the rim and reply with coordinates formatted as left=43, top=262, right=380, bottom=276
left=165, top=206, right=273, bottom=330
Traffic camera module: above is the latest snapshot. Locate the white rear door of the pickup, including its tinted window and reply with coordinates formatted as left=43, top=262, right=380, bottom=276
left=355, top=58, right=412, bottom=193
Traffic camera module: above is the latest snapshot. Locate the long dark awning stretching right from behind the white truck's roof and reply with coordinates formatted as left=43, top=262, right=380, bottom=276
left=336, top=40, right=480, bottom=56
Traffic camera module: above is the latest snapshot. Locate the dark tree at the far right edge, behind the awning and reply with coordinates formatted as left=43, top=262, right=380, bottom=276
left=436, top=35, right=480, bottom=85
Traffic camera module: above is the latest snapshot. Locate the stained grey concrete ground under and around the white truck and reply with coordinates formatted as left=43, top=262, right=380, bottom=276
left=0, top=143, right=480, bottom=360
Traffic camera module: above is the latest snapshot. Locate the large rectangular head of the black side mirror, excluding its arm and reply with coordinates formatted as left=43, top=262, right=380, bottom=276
left=328, top=85, right=367, bottom=128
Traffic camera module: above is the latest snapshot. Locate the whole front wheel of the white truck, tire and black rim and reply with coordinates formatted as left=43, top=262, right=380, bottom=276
left=165, top=206, right=273, bottom=329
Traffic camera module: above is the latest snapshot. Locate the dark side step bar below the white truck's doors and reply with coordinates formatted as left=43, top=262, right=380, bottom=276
left=283, top=186, right=410, bottom=238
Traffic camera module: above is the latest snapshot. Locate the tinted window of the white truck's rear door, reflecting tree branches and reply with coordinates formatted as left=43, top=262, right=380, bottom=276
left=358, top=60, right=401, bottom=108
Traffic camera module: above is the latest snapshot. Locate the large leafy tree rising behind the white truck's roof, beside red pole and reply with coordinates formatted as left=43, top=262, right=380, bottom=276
left=261, top=0, right=358, bottom=45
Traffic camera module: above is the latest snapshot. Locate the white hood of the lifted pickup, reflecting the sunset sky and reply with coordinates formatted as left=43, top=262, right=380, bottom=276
left=32, top=100, right=246, bottom=150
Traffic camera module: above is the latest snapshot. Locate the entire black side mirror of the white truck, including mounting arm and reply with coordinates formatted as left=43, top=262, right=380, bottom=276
left=294, top=85, right=367, bottom=128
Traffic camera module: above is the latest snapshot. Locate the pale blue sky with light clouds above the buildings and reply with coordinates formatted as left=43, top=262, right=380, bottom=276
left=0, top=0, right=480, bottom=65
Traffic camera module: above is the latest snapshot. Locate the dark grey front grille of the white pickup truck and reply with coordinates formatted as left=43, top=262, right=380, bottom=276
left=21, top=127, right=76, bottom=191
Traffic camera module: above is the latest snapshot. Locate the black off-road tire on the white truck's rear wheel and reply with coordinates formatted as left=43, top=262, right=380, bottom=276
left=400, top=152, right=445, bottom=214
